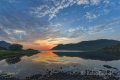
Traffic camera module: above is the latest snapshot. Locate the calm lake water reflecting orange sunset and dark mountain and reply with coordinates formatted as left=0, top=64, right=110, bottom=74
left=0, top=51, right=120, bottom=78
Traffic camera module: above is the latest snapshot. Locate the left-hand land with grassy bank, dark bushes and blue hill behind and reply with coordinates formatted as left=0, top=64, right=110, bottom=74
left=0, top=41, right=39, bottom=57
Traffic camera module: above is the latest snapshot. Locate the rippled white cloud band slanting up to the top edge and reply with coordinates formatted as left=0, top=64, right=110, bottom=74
left=31, top=0, right=100, bottom=20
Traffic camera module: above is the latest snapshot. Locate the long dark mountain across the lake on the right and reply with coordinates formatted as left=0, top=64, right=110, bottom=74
left=52, top=39, right=119, bottom=50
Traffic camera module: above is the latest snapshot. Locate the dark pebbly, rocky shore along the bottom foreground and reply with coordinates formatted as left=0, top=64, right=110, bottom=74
left=0, top=70, right=120, bottom=80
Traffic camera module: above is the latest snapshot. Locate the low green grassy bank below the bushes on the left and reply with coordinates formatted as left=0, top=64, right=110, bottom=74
left=0, top=50, right=38, bottom=57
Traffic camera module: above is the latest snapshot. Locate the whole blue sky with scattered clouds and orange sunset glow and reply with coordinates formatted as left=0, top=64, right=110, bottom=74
left=0, top=0, right=120, bottom=50
